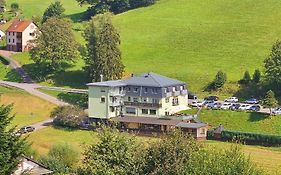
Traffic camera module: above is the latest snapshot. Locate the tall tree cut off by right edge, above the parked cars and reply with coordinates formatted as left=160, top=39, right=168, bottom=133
left=264, top=41, right=281, bottom=85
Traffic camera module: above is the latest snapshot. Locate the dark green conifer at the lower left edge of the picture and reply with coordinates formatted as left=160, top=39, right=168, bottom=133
left=0, top=105, right=27, bottom=175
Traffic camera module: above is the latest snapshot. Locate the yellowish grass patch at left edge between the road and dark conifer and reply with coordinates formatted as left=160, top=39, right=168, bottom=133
left=0, top=86, right=55, bottom=127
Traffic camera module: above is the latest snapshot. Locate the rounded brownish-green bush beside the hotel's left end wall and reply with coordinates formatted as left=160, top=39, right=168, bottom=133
left=51, top=106, right=87, bottom=128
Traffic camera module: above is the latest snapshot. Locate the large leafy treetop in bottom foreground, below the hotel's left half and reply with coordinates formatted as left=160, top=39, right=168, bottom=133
left=77, top=127, right=142, bottom=175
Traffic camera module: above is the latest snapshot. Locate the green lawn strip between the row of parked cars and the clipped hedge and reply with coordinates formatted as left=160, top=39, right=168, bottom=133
left=194, top=110, right=281, bottom=135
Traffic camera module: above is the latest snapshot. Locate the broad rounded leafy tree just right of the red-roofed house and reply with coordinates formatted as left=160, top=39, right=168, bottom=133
left=30, top=18, right=79, bottom=75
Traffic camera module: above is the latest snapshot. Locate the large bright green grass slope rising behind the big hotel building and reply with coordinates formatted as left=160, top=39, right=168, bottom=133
left=114, top=0, right=281, bottom=93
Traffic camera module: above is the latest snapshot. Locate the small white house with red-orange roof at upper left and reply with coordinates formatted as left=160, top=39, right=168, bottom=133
left=6, top=20, right=37, bottom=52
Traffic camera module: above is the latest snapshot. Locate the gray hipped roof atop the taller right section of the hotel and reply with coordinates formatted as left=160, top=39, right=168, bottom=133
left=123, top=72, right=185, bottom=87
